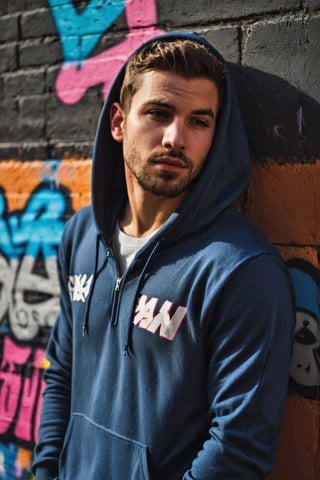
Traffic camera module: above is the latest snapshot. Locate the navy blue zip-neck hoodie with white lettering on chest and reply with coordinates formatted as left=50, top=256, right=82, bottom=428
left=33, top=33, right=294, bottom=480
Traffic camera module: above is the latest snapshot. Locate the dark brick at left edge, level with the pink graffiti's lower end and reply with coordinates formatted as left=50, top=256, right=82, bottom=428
left=3, top=70, right=46, bottom=98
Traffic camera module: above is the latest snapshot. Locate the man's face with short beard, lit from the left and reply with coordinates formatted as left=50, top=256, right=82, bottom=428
left=110, top=71, right=219, bottom=198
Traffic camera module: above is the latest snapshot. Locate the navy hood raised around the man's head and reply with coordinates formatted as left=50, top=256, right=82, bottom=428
left=92, top=32, right=251, bottom=243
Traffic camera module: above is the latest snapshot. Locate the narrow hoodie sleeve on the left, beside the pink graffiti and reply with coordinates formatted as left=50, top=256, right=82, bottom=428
left=32, top=225, right=72, bottom=480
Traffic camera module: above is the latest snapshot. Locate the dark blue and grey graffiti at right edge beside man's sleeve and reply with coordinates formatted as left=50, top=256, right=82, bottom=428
left=287, top=259, right=320, bottom=398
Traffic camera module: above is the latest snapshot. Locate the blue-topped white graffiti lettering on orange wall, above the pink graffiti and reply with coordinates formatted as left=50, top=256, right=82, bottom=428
left=0, top=184, right=66, bottom=341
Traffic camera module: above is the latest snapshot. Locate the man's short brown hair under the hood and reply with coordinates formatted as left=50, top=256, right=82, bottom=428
left=120, top=39, right=224, bottom=111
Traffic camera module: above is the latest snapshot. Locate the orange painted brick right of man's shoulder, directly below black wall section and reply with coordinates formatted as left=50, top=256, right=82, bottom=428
left=247, top=161, right=320, bottom=246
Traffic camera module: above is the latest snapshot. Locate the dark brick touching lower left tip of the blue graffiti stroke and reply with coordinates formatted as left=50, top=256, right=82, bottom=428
left=20, top=39, right=62, bottom=67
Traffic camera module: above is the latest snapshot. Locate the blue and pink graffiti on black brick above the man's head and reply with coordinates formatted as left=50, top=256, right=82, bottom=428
left=48, top=0, right=164, bottom=104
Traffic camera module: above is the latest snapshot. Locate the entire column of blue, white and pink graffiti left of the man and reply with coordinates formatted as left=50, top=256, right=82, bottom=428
left=0, top=160, right=72, bottom=480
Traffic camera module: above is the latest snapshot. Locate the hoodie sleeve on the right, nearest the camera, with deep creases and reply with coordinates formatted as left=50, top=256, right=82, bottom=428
left=183, top=255, right=295, bottom=480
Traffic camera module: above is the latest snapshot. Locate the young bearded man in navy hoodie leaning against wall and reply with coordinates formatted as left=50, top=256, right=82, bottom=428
left=33, top=33, right=294, bottom=480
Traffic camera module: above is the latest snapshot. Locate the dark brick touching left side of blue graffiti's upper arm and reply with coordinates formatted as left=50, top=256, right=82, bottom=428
left=21, top=8, right=57, bottom=39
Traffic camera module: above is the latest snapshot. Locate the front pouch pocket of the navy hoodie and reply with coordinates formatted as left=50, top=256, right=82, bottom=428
left=59, top=413, right=149, bottom=480
